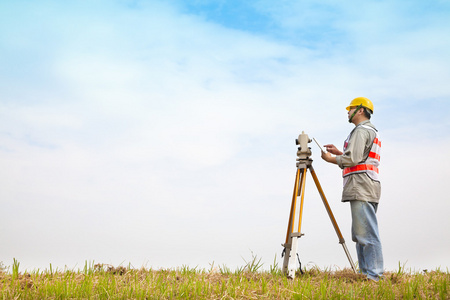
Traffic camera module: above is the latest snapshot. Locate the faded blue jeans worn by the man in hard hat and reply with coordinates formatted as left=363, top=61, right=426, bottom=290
left=350, top=201, right=383, bottom=281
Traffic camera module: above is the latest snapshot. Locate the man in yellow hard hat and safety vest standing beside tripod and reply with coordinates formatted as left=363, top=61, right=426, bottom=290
left=322, top=97, right=383, bottom=281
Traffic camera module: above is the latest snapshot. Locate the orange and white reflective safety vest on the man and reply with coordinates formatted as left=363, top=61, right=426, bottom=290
left=342, top=125, right=381, bottom=181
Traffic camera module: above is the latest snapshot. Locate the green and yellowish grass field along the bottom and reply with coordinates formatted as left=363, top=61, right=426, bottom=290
left=0, top=257, right=450, bottom=299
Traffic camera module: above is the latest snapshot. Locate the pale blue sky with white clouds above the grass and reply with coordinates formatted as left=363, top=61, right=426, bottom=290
left=0, top=0, right=450, bottom=271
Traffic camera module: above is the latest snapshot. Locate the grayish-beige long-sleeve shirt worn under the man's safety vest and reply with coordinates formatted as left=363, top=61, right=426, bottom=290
left=336, top=120, right=381, bottom=203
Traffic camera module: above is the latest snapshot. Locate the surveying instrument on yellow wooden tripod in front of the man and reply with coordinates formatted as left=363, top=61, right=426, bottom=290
left=281, top=131, right=356, bottom=279
